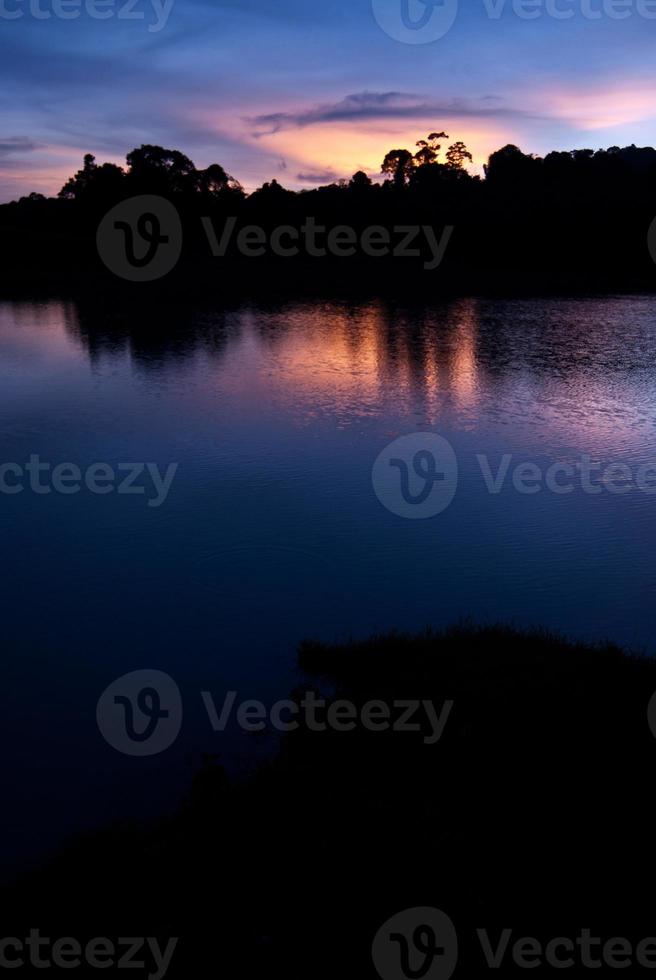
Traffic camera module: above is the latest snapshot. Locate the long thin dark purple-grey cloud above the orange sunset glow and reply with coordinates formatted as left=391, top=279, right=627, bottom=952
left=246, top=92, right=536, bottom=137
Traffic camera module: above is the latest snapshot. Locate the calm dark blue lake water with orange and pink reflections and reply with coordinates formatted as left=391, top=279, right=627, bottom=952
left=0, top=297, right=656, bottom=861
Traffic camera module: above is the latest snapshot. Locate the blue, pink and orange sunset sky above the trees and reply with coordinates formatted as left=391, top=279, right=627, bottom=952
left=0, top=0, right=656, bottom=201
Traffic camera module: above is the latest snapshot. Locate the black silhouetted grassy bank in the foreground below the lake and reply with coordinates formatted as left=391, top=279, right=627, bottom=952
left=1, top=628, right=656, bottom=980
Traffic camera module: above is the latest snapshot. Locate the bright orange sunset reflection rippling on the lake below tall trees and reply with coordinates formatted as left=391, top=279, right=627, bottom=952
left=231, top=300, right=479, bottom=425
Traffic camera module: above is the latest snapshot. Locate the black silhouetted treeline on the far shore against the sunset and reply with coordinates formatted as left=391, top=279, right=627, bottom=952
left=0, top=132, right=656, bottom=292
